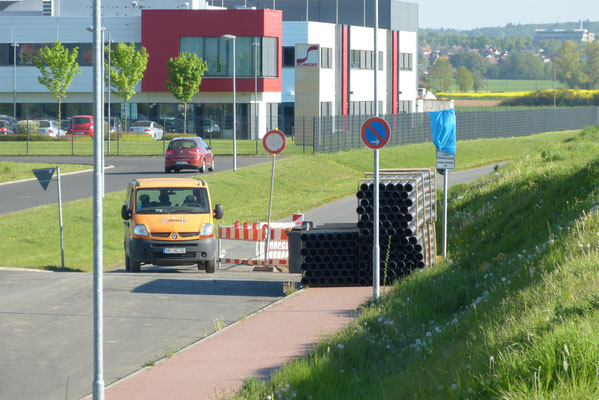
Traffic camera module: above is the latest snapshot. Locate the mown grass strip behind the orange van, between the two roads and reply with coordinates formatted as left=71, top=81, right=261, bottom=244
left=0, top=132, right=576, bottom=271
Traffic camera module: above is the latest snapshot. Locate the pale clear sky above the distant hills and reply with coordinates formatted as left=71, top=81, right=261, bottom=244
left=405, top=0, right=599, bottom=33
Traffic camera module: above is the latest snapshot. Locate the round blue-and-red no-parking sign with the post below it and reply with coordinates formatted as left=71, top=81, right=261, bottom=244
left=360, top=117, right=391, bottom=300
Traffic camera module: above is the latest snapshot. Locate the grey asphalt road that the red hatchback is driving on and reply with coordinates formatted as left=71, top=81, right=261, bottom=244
left=0, top=156, right=270, bottom=214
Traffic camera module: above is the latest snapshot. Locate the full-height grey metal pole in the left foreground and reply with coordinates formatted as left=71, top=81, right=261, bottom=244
left=93, top=0, right=104, bottom=400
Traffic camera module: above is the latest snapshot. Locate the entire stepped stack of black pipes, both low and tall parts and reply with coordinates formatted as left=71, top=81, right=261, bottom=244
left=300, top=169, right=437, bottom=287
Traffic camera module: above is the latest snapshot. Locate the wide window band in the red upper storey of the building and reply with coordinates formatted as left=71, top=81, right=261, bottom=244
left=179, top=37, right=278, bottom=77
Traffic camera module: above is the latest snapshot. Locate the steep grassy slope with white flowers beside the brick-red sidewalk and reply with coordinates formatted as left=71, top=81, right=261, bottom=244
left=221, top=128, right=599, bottom=400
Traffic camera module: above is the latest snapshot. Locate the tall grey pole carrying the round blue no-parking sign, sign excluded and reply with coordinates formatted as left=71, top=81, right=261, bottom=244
left=372, top=0, right=381, bottom=300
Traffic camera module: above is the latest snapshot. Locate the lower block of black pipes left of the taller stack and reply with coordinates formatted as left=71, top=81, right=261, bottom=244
left=300, top=229, right=358, bottom=287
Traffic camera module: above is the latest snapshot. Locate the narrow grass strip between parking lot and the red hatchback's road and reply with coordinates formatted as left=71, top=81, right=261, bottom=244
left=0, top=134, right=312, bottom=156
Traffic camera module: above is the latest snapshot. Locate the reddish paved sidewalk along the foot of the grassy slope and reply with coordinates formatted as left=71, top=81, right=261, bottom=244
left=106, top=287, right=372, bottom=400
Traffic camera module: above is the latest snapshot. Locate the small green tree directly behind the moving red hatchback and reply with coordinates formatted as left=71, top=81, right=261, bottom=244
left=165, top=53, right=208, bottom=133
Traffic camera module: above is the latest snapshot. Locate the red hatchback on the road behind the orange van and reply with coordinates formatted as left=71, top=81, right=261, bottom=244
left=164, top=137, right=214, bottom=174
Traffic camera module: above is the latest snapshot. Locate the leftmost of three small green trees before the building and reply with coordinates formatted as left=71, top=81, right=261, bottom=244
left=33, top=40, right=81, bottom=133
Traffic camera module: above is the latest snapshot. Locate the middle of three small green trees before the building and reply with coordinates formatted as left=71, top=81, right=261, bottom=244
left=105, top=42, right=148, bottom=131
